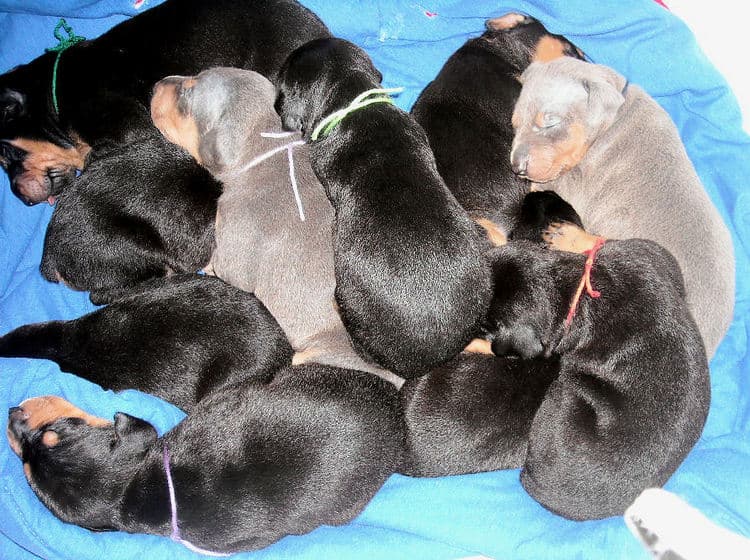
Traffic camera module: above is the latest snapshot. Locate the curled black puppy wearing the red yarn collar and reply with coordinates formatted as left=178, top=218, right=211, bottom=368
left=489, top=235, right=709, bottom=519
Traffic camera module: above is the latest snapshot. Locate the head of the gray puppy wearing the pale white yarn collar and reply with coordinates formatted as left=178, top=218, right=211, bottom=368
left=151, top=68, right=280, bottom=173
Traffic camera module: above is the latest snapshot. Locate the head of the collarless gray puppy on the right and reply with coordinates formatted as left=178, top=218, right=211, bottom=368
left=510, top=57, right=626, bottom=183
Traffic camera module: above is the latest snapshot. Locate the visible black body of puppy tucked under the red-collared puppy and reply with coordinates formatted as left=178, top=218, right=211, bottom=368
left=401, top=353, right=559, bottom=476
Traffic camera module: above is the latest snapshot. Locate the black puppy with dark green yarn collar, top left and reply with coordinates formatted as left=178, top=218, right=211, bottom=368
left=0, top=0, right=329, bottom=204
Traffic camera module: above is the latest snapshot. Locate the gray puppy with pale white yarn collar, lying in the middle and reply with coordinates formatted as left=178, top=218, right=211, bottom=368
left=151, top=68, right=402, bottom=386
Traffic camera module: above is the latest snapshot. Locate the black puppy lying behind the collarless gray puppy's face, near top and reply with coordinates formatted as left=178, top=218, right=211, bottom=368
left=411, top=14, right=581, bottom=235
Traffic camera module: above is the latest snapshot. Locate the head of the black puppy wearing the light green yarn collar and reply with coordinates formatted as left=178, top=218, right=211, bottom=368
left=275, top=38, right=383, bottom=138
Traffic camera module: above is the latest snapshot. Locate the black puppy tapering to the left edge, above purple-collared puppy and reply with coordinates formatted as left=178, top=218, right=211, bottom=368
left=0, top=274, right=292, bottom=411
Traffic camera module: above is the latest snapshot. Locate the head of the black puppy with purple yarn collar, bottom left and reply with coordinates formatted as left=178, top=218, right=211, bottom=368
left=7, top=396, right=157, bottom=529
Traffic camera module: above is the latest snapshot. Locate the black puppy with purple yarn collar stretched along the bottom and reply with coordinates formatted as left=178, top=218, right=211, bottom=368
left=7, top=364, right=403, bottom=552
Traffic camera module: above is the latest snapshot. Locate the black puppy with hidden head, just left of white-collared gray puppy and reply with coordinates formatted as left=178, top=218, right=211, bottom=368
left=41, top=131, right=221, bottom=304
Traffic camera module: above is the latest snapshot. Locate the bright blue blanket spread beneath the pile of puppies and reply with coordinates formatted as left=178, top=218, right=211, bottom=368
left=0, top=0, right=750, bottom=560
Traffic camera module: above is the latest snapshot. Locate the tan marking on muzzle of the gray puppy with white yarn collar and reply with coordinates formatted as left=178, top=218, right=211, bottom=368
left=151, top=78, right=202, bottom=163
